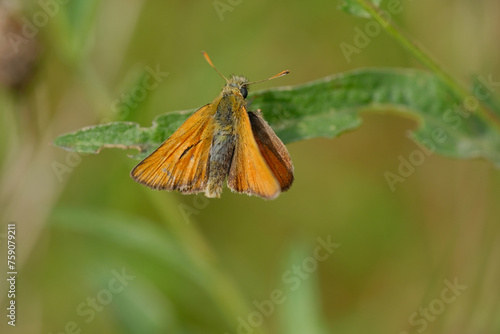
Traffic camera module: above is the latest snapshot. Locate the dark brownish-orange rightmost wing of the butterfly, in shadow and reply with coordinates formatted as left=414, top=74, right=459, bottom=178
left=248, top=111, right=294, bottom=191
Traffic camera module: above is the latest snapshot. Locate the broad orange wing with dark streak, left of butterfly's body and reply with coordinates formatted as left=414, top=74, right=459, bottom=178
left=130, top=104, right=216, bottom=194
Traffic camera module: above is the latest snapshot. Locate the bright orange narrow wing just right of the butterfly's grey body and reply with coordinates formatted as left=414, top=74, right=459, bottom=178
left=227, top=106, right=281, bottom=199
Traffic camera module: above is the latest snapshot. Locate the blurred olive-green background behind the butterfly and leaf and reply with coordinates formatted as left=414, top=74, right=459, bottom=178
left=0, top=0, right=500, bottom=334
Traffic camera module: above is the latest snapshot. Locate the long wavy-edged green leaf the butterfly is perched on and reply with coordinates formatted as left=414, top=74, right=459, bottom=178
left=54, top=69, right=500, bottom=167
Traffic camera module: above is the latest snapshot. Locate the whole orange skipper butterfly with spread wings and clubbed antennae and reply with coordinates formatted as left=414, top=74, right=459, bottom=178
left=130, top=52, right=293, bottom=199
